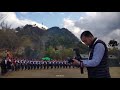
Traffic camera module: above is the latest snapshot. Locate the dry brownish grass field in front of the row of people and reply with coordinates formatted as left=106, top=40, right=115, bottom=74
left=0, top=67, right=120, bottom=78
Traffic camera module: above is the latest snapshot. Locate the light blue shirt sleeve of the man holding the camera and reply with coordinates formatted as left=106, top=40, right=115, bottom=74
left=82, top=43, right=105, bottom=67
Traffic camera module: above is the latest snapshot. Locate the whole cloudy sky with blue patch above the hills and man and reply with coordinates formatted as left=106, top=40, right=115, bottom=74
left=0, top=12, right=120, bottom=43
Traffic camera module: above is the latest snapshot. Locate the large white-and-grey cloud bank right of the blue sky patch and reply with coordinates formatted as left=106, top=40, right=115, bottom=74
left=64, top=12, right=120, bottom=47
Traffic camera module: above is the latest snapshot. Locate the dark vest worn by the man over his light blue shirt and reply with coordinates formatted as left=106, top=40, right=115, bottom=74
left=87, top=38, right=110, bottom=78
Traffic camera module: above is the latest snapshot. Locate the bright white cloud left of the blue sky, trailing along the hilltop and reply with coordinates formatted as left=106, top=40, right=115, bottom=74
left=0, top=12, right=48, bottom=29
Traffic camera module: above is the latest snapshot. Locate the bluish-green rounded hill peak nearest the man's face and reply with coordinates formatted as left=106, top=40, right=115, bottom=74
left=45, top=27, right=79, bottom=48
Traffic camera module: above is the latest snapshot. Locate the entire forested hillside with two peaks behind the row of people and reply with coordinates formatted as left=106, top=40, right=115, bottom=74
left=0, top=24, right=87, bottom=57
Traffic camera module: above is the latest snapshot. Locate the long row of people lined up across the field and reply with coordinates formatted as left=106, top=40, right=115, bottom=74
left=0, top=57, right=78, bottom=75
